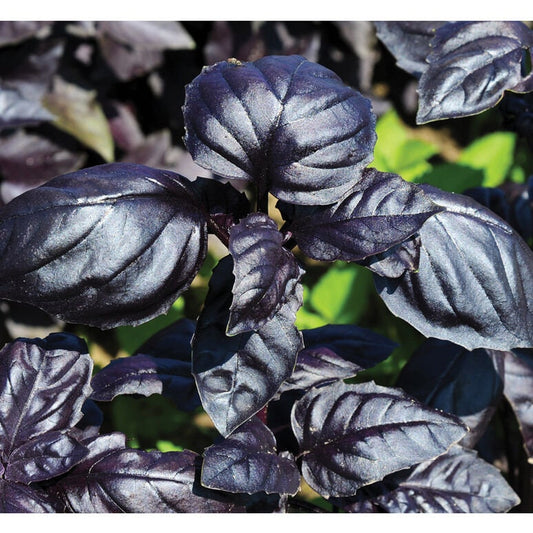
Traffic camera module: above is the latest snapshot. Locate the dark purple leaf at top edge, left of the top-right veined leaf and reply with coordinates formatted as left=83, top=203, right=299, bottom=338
left=374, top=20, right=446, bottom=78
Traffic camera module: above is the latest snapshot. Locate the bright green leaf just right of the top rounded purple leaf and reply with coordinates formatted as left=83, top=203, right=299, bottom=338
left=371, top=110, right=439, bottom=181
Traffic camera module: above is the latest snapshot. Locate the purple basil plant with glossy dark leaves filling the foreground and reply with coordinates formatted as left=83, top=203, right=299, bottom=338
left=0, top=23, right=533, bottom=513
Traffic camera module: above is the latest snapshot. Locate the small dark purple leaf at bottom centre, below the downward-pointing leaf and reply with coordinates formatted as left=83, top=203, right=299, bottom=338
left=202, top=417, right=300, bottom=496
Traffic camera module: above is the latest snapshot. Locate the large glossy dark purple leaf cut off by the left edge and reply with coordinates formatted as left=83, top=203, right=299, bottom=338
left=0, top=163, right=207, bottom=329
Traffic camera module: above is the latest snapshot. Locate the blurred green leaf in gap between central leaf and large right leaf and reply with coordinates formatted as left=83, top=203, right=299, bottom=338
left=304, top=261, right=373, bottom=327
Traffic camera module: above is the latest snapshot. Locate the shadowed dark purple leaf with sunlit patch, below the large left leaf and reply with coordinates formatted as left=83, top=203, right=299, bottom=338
left=91, top=318, right=200, bottom=411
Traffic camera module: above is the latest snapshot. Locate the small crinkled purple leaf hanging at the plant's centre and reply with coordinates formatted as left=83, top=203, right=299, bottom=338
left=228, top=213, right=304, bottom=335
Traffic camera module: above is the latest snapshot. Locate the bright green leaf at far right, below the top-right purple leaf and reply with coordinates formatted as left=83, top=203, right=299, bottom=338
left=457, top=131, right=516, bottom=187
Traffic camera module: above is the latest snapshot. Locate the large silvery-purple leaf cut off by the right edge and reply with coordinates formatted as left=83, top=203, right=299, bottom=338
left=374, top=186, right=533, bottom=350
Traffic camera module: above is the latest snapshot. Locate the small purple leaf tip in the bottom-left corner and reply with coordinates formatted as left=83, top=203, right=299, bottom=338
left=0, top=479, right=57, bottom=513
